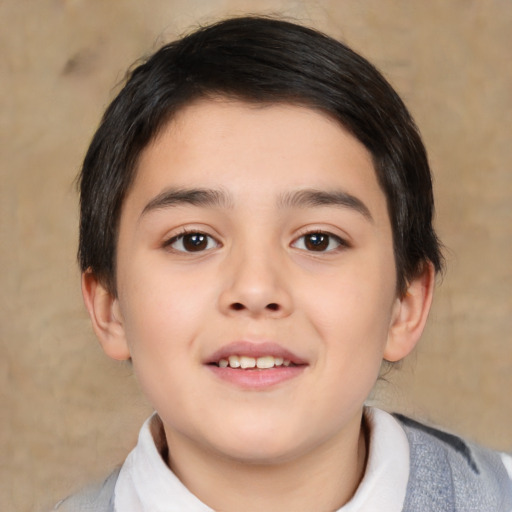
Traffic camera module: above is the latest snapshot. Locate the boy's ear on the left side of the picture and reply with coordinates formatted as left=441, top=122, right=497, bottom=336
left=82, top=270, right=130, bottom=361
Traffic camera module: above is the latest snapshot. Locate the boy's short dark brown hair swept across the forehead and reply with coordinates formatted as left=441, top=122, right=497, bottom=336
left=79, top=17, right=442, bottom=294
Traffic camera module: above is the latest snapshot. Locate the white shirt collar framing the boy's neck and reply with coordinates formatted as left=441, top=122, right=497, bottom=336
left=115, top=408, right=512, bottom=512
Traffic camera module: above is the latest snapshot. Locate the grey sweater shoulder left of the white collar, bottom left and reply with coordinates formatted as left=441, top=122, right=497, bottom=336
left=54, top=468, right=121, bottom=512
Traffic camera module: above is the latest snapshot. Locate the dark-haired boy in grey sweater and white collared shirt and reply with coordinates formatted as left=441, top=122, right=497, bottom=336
left=57, top=18, right=512, bottom=512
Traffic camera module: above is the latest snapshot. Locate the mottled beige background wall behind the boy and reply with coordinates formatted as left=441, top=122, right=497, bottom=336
left=0, top=0, right=512, bottom=512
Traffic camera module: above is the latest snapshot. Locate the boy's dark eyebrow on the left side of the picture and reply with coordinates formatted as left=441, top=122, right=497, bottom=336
left=140, top=188, right=233, bottom=217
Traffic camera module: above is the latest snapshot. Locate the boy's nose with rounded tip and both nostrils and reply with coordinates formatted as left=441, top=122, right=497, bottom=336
left=219, top=249, right=292, bottom=318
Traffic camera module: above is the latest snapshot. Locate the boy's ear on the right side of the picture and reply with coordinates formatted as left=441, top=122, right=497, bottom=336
left=384, top=263, right=435, bottom=362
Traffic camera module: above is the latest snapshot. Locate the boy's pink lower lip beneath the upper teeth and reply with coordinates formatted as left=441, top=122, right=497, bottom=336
left=208, top=365, right=306, bottom=390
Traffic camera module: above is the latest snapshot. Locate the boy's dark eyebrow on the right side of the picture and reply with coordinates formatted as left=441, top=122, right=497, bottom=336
left=278, top=189, right=374, bottom=222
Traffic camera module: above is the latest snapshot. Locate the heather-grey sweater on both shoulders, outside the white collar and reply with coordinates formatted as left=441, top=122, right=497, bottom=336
left=55, top=415, right=512, bottom=512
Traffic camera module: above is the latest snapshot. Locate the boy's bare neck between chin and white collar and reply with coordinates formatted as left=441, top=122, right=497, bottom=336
left=158, top=412, right=367, bottom=512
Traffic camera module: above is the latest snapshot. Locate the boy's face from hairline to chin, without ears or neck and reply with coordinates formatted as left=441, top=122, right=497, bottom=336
left=108, top=100, right=400, bottom=462
